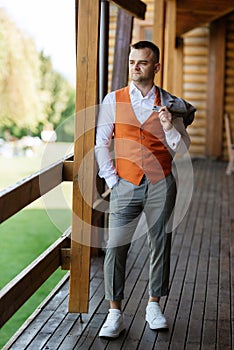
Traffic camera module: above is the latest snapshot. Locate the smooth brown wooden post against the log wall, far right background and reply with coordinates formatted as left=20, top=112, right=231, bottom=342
left=206, top=18, right=226, bottom=157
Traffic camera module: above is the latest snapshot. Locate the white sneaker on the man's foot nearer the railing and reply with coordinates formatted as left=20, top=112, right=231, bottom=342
left=99, top=309, right=125, bottom=338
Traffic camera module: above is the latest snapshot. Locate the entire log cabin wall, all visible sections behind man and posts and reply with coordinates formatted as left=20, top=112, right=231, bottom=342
left=108, top=0, right=234, bottom=159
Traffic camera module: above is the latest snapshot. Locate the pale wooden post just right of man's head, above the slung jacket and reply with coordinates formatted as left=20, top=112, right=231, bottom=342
left=162, top=0, right=176, bottom=93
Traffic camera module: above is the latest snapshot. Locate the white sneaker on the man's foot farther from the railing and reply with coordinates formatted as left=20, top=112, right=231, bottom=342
left=145, top=301, right=168, bottom=330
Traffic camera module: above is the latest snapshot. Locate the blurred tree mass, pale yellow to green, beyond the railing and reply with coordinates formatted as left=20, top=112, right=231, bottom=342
left=0, top=8, right=75, bottom=137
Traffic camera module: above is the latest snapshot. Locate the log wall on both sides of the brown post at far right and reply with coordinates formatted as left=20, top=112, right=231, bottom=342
left=186, top=12, right=234, bottom=160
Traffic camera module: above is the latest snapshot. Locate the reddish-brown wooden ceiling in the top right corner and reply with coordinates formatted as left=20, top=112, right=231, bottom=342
left=176, top=0, right=234, bottom=36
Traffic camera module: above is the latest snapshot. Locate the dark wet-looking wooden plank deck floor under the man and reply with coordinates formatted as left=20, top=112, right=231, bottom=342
left=4, top=159, right=234, bottom=350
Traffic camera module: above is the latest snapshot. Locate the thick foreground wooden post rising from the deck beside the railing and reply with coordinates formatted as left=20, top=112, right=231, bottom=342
left=69, top=0, right=100, bottom=313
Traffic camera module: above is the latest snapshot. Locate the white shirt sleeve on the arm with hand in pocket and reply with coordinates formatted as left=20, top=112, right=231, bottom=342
left=95, top=92, right=119, bottom=188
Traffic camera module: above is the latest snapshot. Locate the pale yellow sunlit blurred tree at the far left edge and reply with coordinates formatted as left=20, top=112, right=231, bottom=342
left=0, top=9, right=42, bottom=135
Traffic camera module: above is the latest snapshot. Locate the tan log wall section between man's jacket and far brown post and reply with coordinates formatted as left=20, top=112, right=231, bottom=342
left=183, top=27, right=209, bottom=156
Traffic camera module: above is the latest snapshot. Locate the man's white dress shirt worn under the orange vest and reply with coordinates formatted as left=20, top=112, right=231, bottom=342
left=95, top=83, right=190, bottom=188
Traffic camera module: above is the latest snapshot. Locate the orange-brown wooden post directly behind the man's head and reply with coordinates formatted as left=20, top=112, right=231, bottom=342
left=153, top=0, right=165, bottom=86
